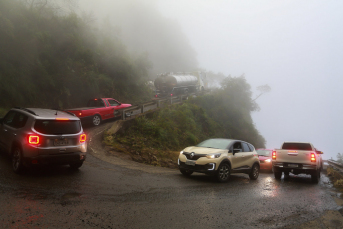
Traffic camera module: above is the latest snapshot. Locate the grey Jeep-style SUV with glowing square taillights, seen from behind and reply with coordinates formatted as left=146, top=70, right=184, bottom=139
left=0, top=107, right=87, bottom=173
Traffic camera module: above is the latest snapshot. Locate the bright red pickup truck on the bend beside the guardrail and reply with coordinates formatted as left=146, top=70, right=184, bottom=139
left=67, top=98, right=132, bottom=126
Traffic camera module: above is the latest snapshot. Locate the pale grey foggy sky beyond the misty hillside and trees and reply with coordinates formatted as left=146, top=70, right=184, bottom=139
left=79, top=0, right=343, bottom=159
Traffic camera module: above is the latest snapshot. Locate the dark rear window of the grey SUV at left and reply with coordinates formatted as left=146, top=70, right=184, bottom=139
left=34, top=120, right=81, bottom=134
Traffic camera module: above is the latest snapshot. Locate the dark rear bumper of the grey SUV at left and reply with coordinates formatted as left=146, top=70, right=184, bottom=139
left=24, top=152, right=86, bottom=166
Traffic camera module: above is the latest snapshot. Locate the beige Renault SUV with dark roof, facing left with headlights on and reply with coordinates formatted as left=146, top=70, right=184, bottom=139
left=178, top=138, right=260, bottom=182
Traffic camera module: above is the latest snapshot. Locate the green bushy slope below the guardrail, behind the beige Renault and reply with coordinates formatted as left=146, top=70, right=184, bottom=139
left=105, top=76, right=265, bottom=167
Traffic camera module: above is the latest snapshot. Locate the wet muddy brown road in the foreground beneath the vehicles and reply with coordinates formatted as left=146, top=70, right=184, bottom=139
left=0, top=123, right=343, bottom=228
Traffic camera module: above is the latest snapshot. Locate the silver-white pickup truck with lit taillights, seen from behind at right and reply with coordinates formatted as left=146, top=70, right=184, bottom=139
left=272, top=142, right=323, bottom=183
